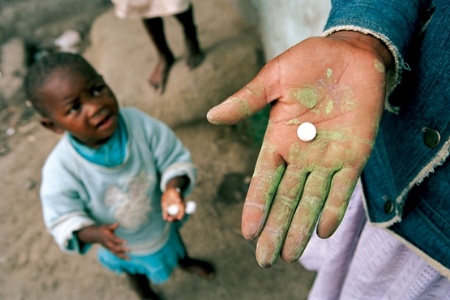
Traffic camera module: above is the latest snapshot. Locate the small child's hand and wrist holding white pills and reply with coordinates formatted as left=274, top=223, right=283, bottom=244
left=161, top=175, right=189, bottom=222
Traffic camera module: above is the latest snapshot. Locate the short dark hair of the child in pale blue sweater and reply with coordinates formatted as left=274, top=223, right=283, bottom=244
left=24, top=52, right=97, bottom=116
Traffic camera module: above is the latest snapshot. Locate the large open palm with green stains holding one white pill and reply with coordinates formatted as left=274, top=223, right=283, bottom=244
left=207, top=31, right=392, bottom=267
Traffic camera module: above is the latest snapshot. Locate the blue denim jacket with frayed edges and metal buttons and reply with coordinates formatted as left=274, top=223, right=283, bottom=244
left=325, top=0, right=450, bottom=274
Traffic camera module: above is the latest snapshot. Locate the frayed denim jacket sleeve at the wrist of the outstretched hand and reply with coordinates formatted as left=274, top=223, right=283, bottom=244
left=322, top=0, right=431, bottom=111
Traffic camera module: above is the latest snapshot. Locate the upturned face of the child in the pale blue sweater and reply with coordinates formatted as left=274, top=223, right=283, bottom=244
left=39, top=67, right=119, bottom=147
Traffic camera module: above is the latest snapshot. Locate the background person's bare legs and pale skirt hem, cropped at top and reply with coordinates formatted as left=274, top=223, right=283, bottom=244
left=112, top=0, right=204, bottom=94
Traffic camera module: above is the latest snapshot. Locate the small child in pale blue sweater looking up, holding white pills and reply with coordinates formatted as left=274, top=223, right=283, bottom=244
left=25, top=53, right=214, bottom=299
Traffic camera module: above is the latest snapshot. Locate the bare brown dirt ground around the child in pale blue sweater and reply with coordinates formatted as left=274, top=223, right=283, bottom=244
left=0, top=1, right=315, bottom=300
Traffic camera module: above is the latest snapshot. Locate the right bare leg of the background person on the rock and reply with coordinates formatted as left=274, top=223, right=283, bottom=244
left=175, top=5, right=204, bottom=69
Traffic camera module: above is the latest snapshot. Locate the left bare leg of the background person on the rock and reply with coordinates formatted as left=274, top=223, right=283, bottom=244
left=143, top=18, right=175, bottom=94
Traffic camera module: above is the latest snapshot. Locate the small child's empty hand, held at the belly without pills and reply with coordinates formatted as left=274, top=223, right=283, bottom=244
left=78, top=223, right=128, bottom=259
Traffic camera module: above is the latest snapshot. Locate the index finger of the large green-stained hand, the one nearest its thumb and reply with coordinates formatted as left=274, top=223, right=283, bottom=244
left=241, top=141, right=285, bottom=239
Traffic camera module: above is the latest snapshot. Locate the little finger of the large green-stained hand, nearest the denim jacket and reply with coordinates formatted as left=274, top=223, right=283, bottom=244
left=317, top=168, right=360, bottom=238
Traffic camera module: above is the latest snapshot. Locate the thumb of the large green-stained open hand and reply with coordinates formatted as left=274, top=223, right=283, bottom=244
left=206, top=62, right=277, bottom=125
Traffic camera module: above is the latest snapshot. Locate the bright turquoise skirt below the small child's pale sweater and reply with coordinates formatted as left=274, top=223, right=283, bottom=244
left=97, top=226, right=186, bottom=284
